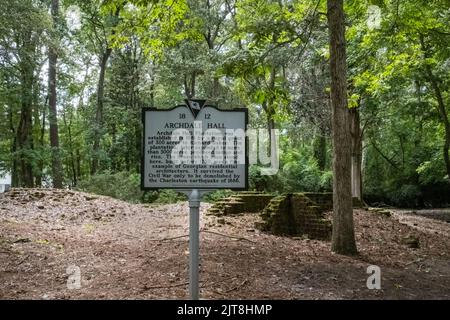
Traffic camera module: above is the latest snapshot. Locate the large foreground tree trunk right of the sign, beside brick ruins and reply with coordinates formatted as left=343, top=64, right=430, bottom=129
left=327, top=0, right=357, bottom=255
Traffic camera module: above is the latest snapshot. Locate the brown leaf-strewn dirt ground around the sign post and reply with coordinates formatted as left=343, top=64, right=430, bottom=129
left=0, top=189, right=450, bottom=299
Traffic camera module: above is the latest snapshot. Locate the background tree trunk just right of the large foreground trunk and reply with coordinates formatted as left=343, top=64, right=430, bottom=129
left=350, top=108, right=362, bottom=200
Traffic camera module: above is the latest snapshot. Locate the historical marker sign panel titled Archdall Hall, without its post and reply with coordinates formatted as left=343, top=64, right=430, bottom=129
left=141, top=100, right=248, bottom=190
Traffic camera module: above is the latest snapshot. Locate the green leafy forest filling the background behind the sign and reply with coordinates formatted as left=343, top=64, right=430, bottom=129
left=0, top=0, right=450, bottom=207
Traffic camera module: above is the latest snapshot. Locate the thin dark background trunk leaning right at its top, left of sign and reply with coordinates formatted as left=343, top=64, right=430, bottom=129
left=91, top=48, right=112, bottom=175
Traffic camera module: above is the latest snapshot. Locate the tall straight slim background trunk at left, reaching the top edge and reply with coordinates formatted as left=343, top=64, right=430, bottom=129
left=48, top=0, right=63, bottom=189
